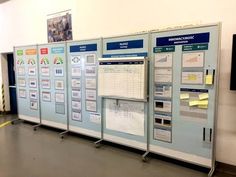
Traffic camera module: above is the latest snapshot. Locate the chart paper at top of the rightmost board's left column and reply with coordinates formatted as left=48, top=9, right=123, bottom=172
left=155, top=53, right=173, bottom=67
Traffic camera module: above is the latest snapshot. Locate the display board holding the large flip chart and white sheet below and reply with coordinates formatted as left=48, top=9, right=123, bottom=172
left=98, top=34, right=148, bottom=150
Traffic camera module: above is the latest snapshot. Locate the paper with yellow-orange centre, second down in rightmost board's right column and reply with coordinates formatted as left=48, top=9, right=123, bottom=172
left=182, top=72, right=203, bottom=84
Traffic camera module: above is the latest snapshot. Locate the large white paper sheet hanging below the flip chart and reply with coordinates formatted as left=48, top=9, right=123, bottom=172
left=105, top=99, right=144, bottom=136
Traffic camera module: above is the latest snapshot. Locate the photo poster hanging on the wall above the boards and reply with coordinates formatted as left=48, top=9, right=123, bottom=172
left=47, top=10, right=73, bottom=43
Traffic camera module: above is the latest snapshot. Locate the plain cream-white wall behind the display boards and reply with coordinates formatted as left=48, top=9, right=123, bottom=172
left=0, top=0, right=236, bottom=165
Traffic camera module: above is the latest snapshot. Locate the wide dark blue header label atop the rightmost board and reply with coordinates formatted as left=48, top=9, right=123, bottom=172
left=156, top=32, right=210, bottom=46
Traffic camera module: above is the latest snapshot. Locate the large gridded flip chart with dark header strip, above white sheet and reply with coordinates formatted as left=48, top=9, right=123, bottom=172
left=98, top=59, right=146, bottom=99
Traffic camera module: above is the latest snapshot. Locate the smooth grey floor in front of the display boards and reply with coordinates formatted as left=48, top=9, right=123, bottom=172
left=0, top=116, right=233, bottom=177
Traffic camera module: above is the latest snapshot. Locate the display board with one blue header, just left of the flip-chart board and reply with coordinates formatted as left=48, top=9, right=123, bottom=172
left=67, top=39, right=102, bottom=138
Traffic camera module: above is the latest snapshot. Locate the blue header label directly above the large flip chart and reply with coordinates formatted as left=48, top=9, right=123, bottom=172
left=107, top=39, right=143, bottom=50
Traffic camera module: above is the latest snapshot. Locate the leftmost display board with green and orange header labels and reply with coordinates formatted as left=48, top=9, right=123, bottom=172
left=14, top=45, right=40, bottom=123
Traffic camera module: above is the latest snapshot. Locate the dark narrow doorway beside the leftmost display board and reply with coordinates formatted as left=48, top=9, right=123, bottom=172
left=7, top=54, right=17, bottom=114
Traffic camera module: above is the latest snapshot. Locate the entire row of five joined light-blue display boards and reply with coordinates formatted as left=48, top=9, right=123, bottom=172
left=14, top=24, right=220, bottom=173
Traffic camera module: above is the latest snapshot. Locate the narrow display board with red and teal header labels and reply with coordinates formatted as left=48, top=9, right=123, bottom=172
left=38, top=43, right=67, bottom=129
